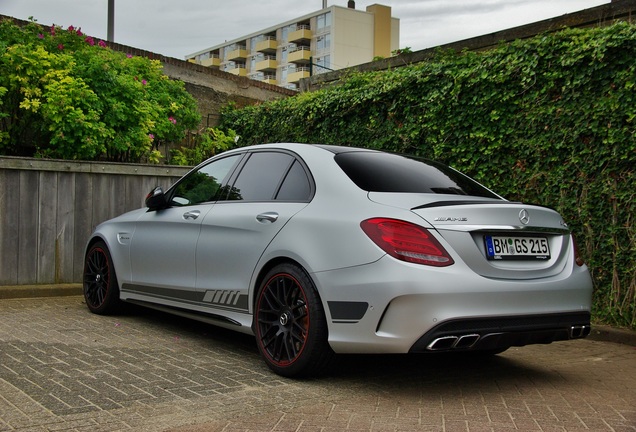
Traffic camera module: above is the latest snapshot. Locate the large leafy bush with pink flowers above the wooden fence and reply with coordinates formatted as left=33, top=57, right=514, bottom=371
left=0, top=20, right=200, bottom=162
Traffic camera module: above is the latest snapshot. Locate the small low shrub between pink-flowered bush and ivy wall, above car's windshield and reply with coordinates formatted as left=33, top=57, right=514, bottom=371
left=171, top=128, right=239, bottom=166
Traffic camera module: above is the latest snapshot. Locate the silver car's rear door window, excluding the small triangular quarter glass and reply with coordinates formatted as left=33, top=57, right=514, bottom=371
left=229, top=152, right=294, bottom=201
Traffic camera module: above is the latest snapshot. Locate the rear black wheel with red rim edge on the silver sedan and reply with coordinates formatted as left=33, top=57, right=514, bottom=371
left=254, top=263, right=334, bottom=378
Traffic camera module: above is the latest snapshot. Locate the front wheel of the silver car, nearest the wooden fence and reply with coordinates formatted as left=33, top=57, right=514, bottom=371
left=83, top=241, right=121, bottom=315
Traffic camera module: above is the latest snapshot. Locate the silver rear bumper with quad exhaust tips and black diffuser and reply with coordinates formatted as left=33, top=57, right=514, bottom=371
left=312, top=257, right=592, bottom=353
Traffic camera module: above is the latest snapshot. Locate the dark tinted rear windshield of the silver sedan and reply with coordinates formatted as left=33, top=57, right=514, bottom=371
left=335, top=151, right=500, bottom=198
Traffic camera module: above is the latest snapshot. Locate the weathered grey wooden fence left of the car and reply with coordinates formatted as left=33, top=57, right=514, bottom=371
left=0, top=156, right=189, bottom=287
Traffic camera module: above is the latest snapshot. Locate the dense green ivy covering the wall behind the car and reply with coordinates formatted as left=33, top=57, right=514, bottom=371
left=222, top=23, right=636, bottom=328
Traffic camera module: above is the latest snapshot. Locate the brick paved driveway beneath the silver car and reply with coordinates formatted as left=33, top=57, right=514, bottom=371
left=0, top=297, right=636, bottom=432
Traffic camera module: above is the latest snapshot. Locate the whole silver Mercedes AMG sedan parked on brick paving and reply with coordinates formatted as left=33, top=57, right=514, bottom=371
left=83, top=144, right=592, bottom=377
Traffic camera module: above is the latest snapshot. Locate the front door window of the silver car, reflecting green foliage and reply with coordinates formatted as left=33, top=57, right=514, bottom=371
left=171, top=154, right=242, bottom=206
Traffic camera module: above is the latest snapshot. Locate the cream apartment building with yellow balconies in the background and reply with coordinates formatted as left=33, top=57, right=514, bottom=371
left=186, top=0, right=400, bottom=89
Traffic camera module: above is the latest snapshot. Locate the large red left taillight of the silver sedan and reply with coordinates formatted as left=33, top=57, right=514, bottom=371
left=360, top=218, right=454, bottom=267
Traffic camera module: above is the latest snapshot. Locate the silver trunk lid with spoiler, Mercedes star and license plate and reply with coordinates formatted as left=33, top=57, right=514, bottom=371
left=369, top=193, right=574, bottom=280
